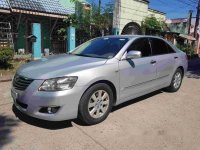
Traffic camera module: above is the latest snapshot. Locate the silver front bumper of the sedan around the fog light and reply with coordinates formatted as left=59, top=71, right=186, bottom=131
left=11, top=80, right=86, bottom=121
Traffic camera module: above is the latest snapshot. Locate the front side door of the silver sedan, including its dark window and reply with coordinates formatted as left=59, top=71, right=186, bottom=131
left=119, top=38, right=156, bottom=102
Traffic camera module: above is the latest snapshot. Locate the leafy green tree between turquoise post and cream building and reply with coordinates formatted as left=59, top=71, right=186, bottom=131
left=58, top=0, right=113, bottom=45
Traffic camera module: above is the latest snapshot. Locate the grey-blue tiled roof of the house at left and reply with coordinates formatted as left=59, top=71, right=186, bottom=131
left=0, top=0, right=75, bottom=16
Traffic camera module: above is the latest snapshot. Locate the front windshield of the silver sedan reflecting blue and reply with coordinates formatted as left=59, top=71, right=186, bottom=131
left=70, top=37, right=129, bottom=59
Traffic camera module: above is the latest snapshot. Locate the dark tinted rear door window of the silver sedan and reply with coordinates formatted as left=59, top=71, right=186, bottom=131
left=150, top=38, right=168, bottom=55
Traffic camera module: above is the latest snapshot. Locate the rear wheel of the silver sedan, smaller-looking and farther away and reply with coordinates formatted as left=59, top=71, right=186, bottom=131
left=165, top=68, right=183, bottom=92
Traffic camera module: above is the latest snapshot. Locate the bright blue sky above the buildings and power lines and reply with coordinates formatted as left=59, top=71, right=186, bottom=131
left=89, top=0, right=197, bottom=19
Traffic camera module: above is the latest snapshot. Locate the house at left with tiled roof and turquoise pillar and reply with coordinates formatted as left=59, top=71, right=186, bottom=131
left=0, top=0, right=75, bottom=54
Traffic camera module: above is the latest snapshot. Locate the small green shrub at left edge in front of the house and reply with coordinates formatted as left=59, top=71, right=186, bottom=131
left=0, top=48, right=13, bottom=69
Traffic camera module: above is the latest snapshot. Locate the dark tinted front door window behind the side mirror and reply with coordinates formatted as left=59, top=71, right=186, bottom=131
left=127, top=38, right=151, bottom=57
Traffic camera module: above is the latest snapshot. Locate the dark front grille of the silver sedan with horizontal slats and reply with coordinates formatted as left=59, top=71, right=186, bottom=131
left=13, top=75, right=33, bottom=91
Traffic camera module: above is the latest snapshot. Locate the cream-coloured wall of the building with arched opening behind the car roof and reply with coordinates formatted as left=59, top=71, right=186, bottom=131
left=113, top=0, right=165, bottom=34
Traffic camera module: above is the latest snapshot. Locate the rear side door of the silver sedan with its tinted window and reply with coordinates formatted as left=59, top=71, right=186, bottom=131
left=149, top=38, right=176, bottom=86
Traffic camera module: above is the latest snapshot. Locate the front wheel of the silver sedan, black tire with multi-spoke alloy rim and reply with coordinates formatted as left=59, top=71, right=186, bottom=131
left=78, top=83, right=114, bottom=125
